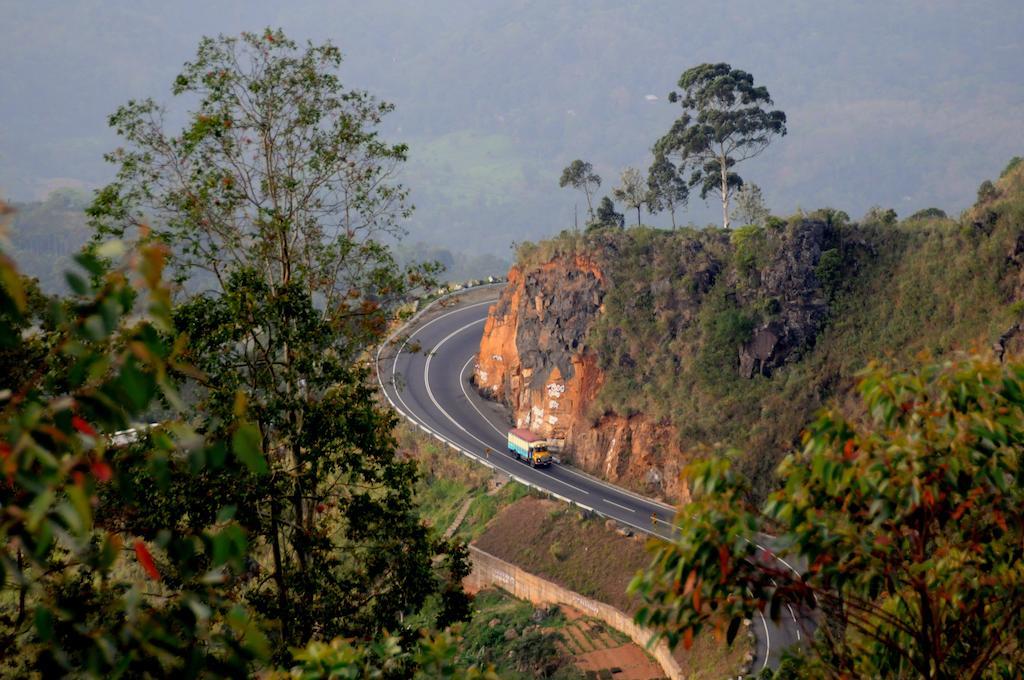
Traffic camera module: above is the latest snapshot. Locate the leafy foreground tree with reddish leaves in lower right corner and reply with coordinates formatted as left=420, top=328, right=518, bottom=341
left=632, top=357, right=1024, bottom=678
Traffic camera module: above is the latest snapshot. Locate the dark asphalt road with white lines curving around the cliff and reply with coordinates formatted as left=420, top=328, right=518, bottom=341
left=377, top=289, right=802, bottom=673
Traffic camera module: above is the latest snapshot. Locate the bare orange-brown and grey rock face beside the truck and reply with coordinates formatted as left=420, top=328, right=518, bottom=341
left=474, top=251, right=688, bottom=501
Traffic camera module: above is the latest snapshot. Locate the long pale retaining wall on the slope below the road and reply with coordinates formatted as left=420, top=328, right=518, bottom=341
left=463, top=546, right=684, bottom=680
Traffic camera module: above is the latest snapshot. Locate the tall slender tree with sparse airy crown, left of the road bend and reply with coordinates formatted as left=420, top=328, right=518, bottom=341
left=90, top=30, right=455, bottom=655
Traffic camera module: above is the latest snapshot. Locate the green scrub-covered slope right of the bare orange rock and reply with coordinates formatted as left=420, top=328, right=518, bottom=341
left=518, top=159, right=1024, bottom=493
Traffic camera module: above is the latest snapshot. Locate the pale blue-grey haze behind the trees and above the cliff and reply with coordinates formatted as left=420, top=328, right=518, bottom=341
left=0, top=0, right=1024, bottom=253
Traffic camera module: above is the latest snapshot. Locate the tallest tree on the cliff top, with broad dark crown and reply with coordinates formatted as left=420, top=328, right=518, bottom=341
left=654, top=63, right=786, bottom=228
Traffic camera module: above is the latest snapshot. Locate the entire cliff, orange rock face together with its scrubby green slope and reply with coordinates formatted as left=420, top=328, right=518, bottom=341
left=475, top=164, right=1024, bottom=501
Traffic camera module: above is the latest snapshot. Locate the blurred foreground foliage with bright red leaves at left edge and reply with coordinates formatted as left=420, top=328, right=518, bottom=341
left=0, top=213, right=267, bottom=677
